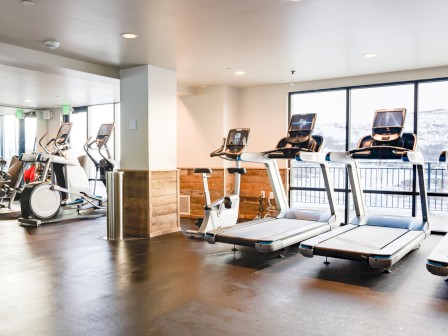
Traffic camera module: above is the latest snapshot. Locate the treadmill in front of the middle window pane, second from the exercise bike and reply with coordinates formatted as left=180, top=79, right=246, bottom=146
left=299, top=108, right=430, bottom=271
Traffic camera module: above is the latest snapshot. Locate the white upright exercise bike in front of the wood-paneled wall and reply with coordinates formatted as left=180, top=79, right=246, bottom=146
left=186, top=128, right=249, bottom=238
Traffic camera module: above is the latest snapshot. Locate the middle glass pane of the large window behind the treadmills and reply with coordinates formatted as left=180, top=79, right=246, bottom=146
left=350, top=84, right=414, bottom=215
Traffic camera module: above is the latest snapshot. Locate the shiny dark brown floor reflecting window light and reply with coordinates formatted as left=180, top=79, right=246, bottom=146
left=0, top=219, right=448, bottom=336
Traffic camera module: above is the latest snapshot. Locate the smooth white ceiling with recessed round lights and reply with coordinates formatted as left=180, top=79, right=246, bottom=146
left=0, top=0, right=448, bottom=108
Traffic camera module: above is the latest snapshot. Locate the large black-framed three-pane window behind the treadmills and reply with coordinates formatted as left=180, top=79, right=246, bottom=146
left=290, top=80, right=448, bottom=230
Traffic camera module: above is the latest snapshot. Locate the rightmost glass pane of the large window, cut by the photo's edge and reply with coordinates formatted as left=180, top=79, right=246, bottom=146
left=418, top=81, right=448, bottom=231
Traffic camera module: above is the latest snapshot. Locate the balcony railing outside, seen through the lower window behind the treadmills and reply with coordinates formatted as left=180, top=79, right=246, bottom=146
left=290, top=162, right=448, bottom=211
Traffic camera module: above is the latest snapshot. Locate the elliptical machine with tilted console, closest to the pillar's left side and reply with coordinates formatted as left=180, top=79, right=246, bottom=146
left=84, top=123, right=115, bottom=194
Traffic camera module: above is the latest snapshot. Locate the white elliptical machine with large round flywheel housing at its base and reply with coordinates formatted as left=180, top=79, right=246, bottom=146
left=19, top=123, right=106, bottom=226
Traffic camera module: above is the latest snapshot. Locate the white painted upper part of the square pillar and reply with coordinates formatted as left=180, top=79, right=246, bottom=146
left=120, top=65, right=177, bottom=170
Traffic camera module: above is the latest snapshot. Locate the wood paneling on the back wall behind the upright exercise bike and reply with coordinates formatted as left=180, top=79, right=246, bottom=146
left=180, top=168, right=287, bottom=219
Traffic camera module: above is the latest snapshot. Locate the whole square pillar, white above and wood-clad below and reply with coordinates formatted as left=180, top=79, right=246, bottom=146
left=120, top=65, right=180, bottom=237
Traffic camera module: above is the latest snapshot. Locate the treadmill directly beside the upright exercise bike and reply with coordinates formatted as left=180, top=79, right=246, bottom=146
left=205, top=113, right=339, bottom=252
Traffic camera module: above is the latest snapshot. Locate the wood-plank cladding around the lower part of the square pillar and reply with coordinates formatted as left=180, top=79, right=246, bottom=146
left=123, top=170, right=180, bottom=237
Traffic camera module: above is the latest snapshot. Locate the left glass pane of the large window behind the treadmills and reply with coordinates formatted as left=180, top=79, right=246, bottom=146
left=290, top=90, right=346, bottom=209
